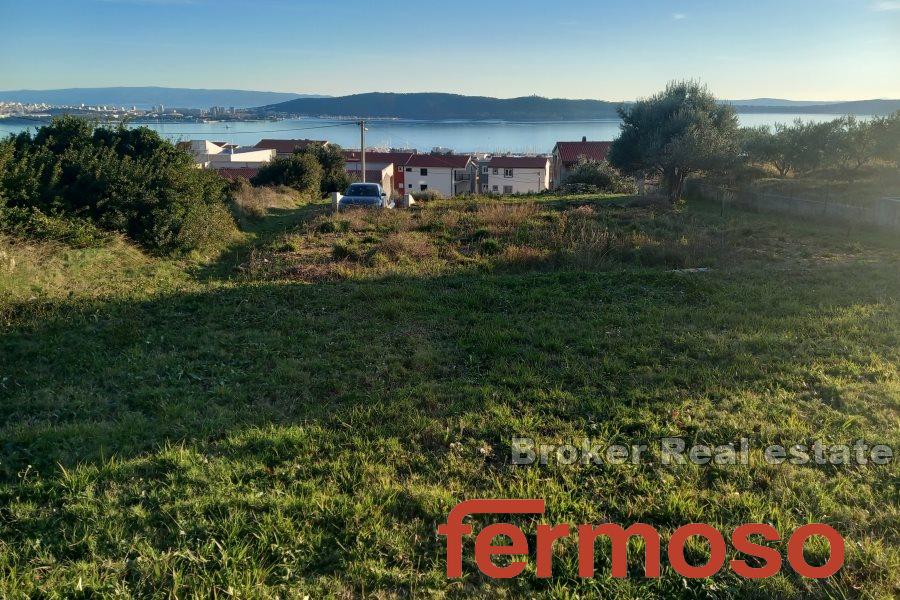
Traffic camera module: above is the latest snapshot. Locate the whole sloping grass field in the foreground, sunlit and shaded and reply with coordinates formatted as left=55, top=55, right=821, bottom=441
left=0, top=197, right=900, bottom=598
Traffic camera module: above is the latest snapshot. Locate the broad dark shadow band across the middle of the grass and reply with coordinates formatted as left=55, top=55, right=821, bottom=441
left=0, top=253, right=890, bottom=477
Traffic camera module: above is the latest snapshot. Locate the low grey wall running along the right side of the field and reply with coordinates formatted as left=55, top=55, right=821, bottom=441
left=687, top=181, right=900, bottom=231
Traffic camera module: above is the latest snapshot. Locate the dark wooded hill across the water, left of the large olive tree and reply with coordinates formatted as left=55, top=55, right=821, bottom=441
left=259, top=93, right=620, bottom=121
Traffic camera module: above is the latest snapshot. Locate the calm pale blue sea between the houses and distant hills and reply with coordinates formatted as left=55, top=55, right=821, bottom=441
left=0, top=114, right=864, bottom=153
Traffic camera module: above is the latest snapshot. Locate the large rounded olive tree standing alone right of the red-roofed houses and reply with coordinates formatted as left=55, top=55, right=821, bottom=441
left=609, top=81, right=739, bottom=202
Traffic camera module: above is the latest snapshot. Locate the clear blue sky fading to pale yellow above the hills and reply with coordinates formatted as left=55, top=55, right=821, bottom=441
left=0, top=0, right=900, bottom=100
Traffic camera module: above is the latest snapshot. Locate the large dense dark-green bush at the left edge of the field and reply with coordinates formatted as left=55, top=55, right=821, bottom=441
left=0, top=117, right=236, bottom=252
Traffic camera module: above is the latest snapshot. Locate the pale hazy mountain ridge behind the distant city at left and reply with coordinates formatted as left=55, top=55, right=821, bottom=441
left=0, top=87, right=321, bottom=108
